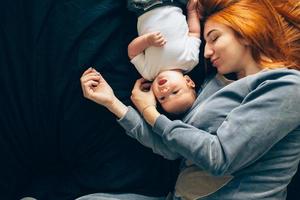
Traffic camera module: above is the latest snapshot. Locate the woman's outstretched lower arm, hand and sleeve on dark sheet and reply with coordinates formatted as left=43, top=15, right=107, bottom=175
left=80, top=68, right=179, bottom=160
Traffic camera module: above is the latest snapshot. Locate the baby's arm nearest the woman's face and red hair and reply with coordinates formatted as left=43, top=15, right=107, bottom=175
left=187, top=0, right=201, bottom=38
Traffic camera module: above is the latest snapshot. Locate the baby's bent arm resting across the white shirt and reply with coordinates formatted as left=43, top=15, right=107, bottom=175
left=128, top=32, right=167, bottom=60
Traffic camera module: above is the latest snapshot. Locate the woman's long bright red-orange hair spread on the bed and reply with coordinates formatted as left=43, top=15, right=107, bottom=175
left=199, top=0, right=300, bottom=70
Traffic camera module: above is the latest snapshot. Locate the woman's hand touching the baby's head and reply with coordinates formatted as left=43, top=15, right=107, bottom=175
left=131, top=78, right=160, bottom=126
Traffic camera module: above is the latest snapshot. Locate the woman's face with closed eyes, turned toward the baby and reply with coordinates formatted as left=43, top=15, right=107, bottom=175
left=204, top=20, right=257, bottom=77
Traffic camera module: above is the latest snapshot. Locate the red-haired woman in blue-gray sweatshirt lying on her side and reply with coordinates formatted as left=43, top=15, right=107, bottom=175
left=81, top=0, right=300, bottom=200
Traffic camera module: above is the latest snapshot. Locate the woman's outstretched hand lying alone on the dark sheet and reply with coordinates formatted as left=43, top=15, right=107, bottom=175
left=80, top=68, right=127, bottom=118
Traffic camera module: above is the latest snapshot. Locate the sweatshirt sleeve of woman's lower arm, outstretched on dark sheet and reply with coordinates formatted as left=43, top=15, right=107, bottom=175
left=118, top=106, right=179, bottom=160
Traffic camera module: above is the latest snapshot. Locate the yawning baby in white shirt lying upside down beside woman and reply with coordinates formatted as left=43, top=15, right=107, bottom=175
left=128, top=0, right=201, bottom=114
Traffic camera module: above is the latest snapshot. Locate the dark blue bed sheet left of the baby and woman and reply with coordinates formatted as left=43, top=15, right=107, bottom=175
left=0, top=0, right=182, bottom=200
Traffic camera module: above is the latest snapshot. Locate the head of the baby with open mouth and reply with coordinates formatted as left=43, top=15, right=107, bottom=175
left=152, top=70, right=196, bottom=114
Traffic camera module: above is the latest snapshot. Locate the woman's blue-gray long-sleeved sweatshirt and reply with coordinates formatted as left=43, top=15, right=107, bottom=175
left=119, top=69, right=300, bottom=200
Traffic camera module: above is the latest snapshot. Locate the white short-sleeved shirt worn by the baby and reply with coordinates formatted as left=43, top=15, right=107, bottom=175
left=131, top=6, right=200, bottom=80
